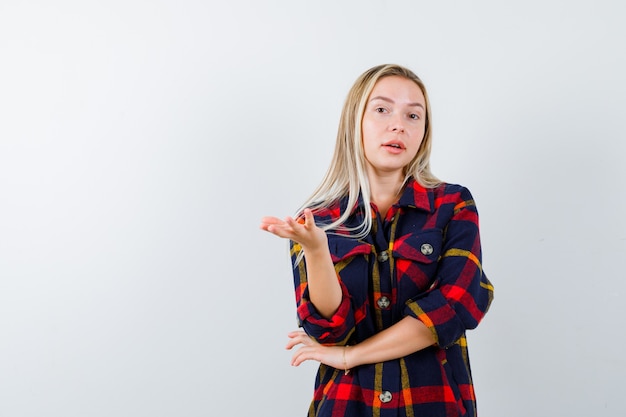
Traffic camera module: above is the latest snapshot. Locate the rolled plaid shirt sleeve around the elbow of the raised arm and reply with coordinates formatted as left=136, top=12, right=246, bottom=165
left=291, top=242, right=355, bottom=345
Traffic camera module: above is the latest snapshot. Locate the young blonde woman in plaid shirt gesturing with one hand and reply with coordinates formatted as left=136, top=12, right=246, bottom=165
left=261, top=65, right=493, bottom=417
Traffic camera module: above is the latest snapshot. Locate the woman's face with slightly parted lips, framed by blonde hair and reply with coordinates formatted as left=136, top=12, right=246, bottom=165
left=361, top=75, right=426, bottom=176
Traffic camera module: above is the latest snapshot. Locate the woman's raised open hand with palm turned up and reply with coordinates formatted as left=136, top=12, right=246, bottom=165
left=261, top=209, right=328, bottom=252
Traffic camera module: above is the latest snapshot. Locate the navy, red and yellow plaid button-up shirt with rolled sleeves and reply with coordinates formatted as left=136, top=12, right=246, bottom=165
left=291, top=180, right=493, bottom=417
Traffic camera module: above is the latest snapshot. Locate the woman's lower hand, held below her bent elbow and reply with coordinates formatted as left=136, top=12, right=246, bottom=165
left=286, top=330, right=350, bottom=370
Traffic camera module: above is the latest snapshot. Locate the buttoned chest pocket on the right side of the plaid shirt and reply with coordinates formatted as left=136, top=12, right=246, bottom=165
left=392, top=229, right=443, bottom=290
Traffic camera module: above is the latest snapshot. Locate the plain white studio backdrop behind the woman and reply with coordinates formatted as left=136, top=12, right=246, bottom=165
left=0, top=0, right=626, bottom=417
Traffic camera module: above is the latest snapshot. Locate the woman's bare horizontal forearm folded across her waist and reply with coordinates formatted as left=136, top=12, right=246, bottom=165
left=345, top=317, right=436, bottom=368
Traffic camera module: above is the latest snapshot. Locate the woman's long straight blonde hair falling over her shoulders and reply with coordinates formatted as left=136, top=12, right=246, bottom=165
left=296, top=64, right=440, bottom=239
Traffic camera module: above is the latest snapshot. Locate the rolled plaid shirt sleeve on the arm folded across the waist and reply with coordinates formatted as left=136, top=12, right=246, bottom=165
left=405, top=188, right=493, bottom=348
